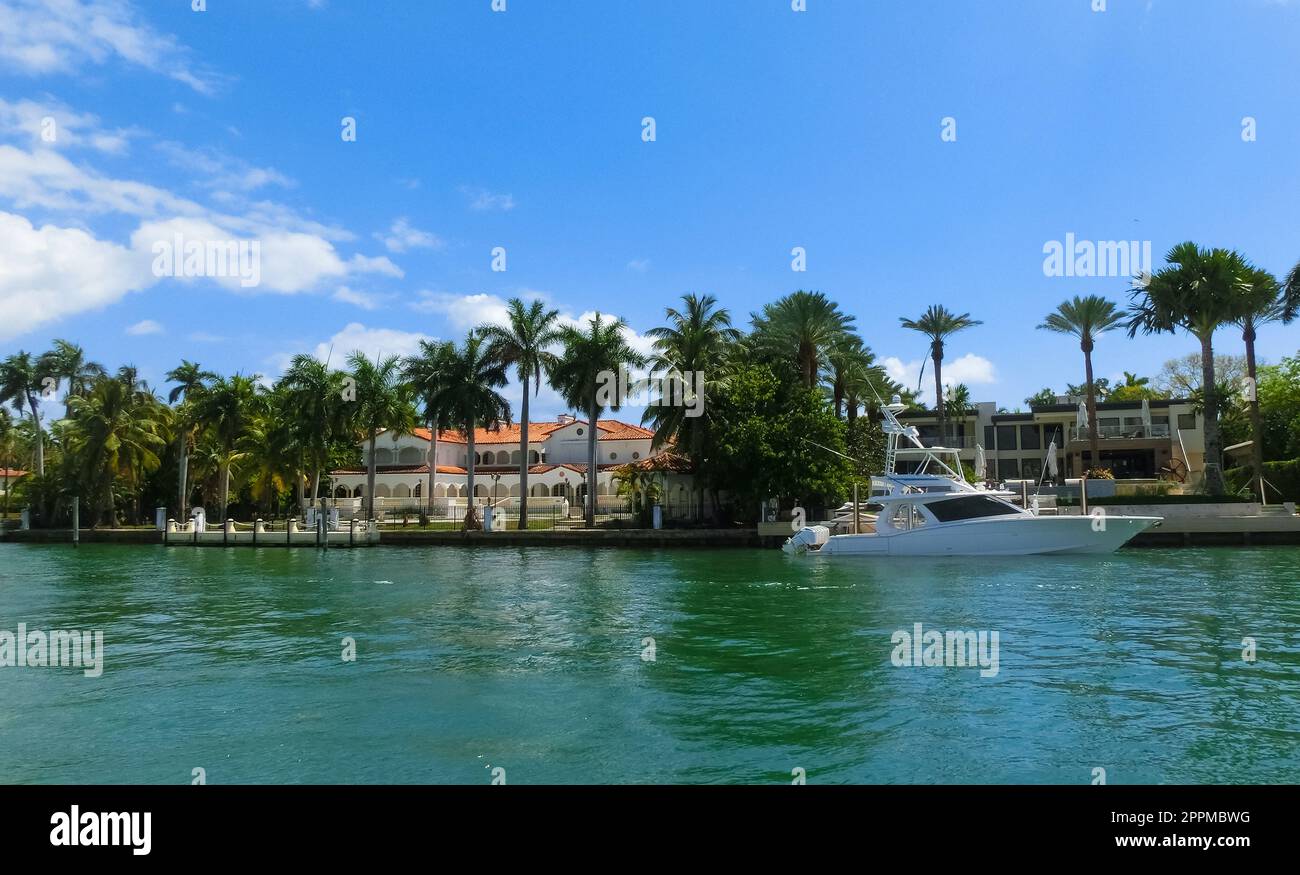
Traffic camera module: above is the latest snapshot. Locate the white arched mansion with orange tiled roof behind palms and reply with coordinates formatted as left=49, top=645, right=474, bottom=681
left=330, top=415, right=689, bottom=508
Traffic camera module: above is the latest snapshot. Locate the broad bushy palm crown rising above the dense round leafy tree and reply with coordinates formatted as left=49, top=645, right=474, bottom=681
left=753, top=290, right=854, bottom=389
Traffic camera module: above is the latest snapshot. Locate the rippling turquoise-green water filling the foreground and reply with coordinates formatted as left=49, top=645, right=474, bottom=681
left=0, top=543, right=1300, bottom=784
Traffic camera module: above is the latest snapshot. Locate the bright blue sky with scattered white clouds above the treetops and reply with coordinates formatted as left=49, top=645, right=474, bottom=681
left=0, top=0, right=1300, bottom=416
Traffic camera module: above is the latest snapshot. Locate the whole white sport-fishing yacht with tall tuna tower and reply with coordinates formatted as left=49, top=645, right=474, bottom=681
left=783, top=397, right=1162, bottom=556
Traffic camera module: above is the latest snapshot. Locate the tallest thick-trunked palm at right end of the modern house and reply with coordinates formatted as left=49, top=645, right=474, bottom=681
left=1128, top=242, right=1247, bottom=495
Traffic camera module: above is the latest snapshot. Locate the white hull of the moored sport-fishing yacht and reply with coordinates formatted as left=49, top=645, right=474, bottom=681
left=816, top=516, right=1161, bottom=556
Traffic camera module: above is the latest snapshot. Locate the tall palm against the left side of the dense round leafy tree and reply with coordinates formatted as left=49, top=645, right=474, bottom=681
left=641, top=294, right=741, bottom=519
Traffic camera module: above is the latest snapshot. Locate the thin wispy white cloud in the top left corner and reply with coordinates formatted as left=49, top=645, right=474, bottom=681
left=0, top=0, right=218, bottom=94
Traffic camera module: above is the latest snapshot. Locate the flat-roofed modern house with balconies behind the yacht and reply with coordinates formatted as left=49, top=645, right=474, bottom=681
left=900, top=395, right=1205, bottom=484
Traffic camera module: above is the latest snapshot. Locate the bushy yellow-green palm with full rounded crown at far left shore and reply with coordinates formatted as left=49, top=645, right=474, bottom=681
left=68, top=377, right=166, bottom=527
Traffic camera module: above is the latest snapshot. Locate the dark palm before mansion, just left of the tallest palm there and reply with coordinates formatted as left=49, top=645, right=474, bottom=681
left=425, top=332, right=510, bottom=529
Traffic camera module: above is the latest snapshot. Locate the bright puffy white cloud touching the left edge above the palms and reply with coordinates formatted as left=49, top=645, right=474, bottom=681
left=0, top=212, right=155, bottom=341
